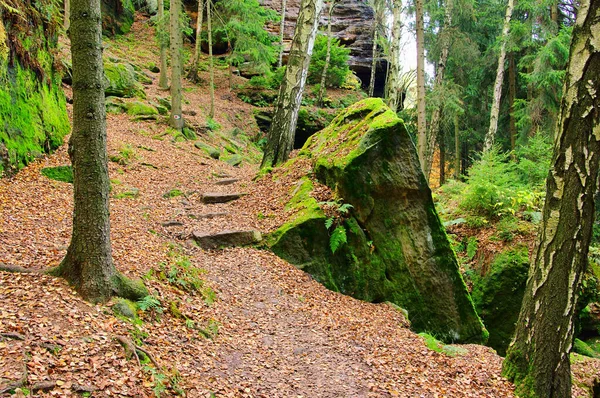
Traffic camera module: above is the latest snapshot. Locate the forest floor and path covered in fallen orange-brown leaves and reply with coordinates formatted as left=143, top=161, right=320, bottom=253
left=0, top=14, right=600, bottom=397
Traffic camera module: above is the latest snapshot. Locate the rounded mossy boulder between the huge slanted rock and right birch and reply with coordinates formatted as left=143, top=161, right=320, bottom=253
left=472, top=246, right=529, bottom=356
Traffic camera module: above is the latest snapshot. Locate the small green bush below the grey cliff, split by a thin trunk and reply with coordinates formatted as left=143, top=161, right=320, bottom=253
left=308, top=35, right=350, bottom=87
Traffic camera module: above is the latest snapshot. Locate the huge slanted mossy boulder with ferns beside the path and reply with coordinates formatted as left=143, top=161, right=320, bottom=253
left=267, top=98, right=487, bottom=342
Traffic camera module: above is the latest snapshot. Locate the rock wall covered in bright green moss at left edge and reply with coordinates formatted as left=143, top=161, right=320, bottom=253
left=0, top=0, right=70, bottom=176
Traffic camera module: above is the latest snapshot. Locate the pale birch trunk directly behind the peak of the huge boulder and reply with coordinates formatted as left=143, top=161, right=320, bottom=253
left=385, top=0, right=402, bottom=112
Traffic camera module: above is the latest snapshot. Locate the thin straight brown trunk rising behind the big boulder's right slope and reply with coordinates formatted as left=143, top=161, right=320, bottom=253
left=415, top=0, right=429, bottom=170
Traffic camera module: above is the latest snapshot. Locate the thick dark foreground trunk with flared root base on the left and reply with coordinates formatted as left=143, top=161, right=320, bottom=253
left=51, top=0, right=145, bottom=303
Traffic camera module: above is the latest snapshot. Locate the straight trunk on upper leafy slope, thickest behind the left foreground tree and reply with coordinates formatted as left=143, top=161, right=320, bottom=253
left=169, top=0, right=183, bottom=131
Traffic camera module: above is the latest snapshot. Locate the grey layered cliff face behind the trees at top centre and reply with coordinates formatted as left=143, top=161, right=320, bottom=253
left=262, top=0, right=375, bottom=84
